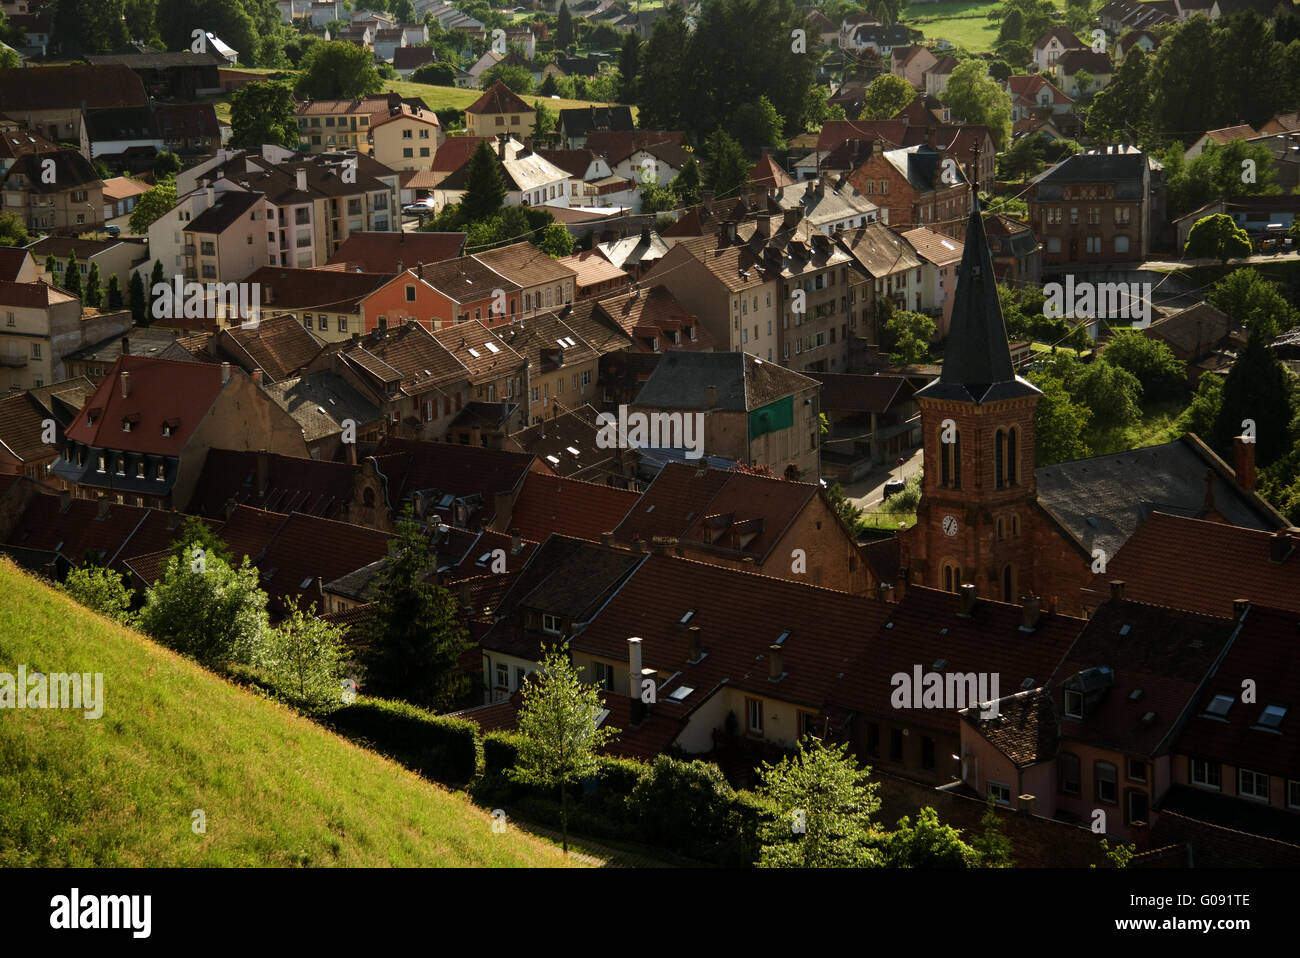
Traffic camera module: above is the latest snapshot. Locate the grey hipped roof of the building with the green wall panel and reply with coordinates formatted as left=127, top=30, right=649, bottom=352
left=636, top=350, right=816, bottom=412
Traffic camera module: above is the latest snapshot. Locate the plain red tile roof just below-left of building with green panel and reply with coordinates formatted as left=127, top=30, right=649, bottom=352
left=510, top=473, right=637, bottom=542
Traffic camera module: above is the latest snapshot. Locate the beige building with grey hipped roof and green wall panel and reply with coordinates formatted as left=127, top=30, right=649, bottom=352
left=629, top=350, right=819, bottom=477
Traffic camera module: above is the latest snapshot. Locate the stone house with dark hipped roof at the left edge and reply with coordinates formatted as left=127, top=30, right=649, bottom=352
left=0, top=149, right=104, bottom=234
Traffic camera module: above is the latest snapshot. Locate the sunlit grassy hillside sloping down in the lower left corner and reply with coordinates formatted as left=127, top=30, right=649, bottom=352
left=0, top=559, right=579, bottom=867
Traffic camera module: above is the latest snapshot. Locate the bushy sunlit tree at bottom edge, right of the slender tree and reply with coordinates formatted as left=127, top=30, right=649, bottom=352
left=757, top=736, right=880, bottom=868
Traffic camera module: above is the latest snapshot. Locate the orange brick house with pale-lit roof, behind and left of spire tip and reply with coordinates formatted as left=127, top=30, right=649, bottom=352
left=849, top=141, right=971, bottom=235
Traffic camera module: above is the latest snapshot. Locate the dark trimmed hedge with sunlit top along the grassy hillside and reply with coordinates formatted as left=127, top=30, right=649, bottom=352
left=329, top=698, right=478, bottom=785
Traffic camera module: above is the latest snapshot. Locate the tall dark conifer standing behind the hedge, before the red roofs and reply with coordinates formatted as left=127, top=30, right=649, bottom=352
left=364, top=511, right=469, bottom=711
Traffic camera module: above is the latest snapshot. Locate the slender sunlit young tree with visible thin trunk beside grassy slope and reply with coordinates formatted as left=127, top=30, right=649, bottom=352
left=510, top=646, right=619, bottom=854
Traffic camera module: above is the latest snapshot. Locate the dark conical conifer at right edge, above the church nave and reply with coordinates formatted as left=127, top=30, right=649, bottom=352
left=1210, top=328, right=1291, bottom=469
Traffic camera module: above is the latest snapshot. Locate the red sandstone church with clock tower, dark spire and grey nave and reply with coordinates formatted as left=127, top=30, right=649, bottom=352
left=898, top=201, right=1288, bottom=615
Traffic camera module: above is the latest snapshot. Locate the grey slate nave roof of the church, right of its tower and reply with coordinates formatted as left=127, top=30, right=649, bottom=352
left=1035, top=434, right=1287, bottom=559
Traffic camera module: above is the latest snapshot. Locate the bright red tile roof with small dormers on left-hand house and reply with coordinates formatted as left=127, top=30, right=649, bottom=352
left=66, top=355, right=228, bottom=456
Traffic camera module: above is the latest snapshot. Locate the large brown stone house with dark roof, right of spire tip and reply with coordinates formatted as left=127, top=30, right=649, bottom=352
left=1028, top=147, right=1164, bottom=266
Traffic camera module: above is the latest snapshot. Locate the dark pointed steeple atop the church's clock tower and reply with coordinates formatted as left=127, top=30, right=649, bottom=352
left=917, top=191, right=1039, bottom=403
